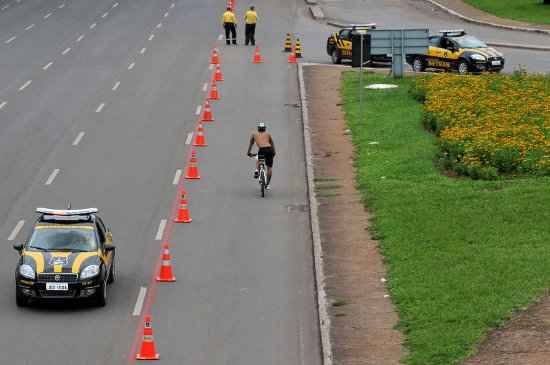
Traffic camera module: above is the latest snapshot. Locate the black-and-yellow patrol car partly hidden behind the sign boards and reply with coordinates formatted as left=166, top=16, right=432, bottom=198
left=327, top=23, right=391, bottom=64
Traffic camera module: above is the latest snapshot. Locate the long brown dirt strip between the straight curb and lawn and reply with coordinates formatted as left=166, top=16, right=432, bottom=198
left=304, top=66, right=405, bottom=365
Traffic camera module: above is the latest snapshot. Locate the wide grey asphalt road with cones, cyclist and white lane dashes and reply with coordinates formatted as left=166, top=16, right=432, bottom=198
left=0, top=0, right=320, bottom=365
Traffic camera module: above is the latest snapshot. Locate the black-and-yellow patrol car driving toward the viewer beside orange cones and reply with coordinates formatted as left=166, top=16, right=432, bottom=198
left=13, top=208, right=116, bottom=306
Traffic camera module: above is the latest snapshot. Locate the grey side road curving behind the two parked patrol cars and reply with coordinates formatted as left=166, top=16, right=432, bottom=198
left=298, top=0, right=550, bottom=73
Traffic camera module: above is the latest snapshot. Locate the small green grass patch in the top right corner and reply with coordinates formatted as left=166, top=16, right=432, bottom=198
left=465, top=0, right=550, bottom=24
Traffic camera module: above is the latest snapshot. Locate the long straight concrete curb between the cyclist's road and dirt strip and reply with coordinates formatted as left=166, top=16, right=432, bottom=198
left=298, top=64, right=332, bottom=365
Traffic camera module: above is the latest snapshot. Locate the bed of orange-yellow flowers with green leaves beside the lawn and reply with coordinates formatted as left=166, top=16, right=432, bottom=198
left=413, top=72, right=550, bottom=179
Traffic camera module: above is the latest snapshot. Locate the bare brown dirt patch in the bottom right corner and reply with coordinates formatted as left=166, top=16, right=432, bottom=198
left=464, top=296, right=550, bottom=365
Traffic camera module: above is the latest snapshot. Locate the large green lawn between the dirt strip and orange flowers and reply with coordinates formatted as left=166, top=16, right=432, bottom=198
left=342, top=72, right=550, bottom=365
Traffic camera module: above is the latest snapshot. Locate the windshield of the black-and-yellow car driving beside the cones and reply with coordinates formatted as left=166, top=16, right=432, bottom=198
left=28, top=226, right=97, bottom=251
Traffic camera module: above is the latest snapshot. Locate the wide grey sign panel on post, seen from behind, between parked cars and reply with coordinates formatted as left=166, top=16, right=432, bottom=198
left=369, top=29, right=429, bottom=77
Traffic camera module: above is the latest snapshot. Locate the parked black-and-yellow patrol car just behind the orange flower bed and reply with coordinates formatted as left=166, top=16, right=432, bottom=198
left=407, top=29, right=504, bottom=74
